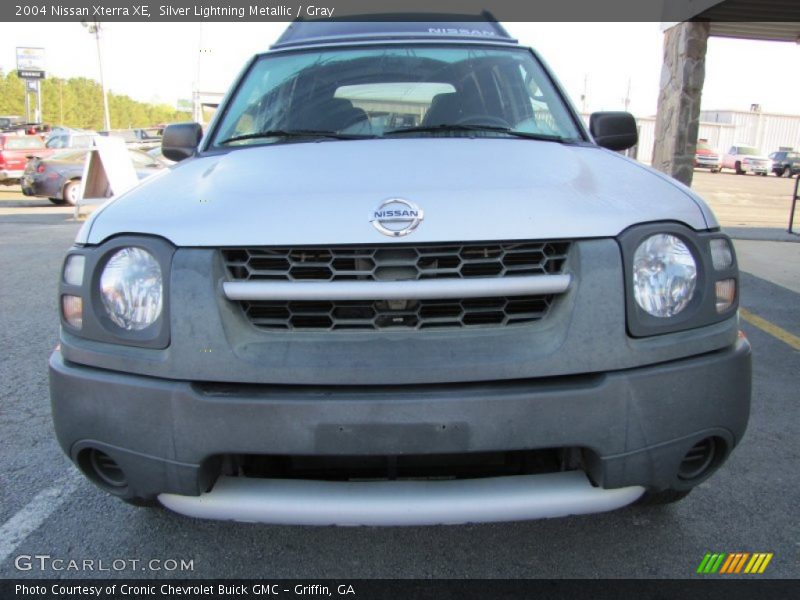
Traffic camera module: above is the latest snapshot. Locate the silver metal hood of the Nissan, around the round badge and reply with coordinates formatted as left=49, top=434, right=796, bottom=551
left=78, top=138, right=715, bottom=246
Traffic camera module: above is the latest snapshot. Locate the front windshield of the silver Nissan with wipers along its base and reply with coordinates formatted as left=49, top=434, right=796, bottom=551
left=212, top=46, right=582, bottom=147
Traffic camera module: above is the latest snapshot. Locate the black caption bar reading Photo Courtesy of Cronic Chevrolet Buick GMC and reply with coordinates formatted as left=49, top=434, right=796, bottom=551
left=0, top=575, right=800, bottom=600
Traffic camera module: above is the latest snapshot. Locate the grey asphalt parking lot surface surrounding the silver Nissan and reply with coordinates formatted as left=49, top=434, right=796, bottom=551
left=0, top=174, right=800, bottom=579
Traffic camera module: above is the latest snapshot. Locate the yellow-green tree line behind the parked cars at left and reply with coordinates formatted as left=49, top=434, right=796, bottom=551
left=0, top=71, right=187, bottom=130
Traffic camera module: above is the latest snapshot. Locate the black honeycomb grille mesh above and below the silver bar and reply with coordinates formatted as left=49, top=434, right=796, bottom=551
left=222, top=242, right=569, bottom=331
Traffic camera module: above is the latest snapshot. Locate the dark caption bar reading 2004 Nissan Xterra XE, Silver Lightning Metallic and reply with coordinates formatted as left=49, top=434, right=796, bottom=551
left=6, top=0, right=800, bottom=23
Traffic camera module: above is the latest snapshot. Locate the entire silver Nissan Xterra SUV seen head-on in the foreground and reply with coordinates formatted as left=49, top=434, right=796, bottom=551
left=50, top=20, right=750, bottom=525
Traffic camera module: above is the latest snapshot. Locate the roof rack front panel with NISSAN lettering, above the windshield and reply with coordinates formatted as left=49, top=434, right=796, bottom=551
left=272, top=11, right=517, bottom=49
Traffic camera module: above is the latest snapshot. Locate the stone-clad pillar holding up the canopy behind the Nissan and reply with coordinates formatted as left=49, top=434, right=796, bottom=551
left=652, top=22, right=709, bottom=185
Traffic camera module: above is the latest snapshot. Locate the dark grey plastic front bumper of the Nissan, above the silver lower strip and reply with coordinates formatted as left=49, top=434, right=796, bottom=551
left=50, top=339, right=750, bottom=516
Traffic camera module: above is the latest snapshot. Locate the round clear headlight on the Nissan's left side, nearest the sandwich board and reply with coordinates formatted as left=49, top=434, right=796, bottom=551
left=100, top=247, right=164, bottom=331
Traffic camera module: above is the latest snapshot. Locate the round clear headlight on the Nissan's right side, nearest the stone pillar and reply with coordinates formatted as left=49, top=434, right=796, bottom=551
left=633, top=233, right=697, bottom=318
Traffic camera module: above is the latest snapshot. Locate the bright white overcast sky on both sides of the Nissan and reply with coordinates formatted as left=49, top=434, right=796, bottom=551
left=0, top=22, right=800, bottom=116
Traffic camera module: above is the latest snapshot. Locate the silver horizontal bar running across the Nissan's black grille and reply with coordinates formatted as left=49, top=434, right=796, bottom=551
left=222, top=275, right=571, bottom=301
